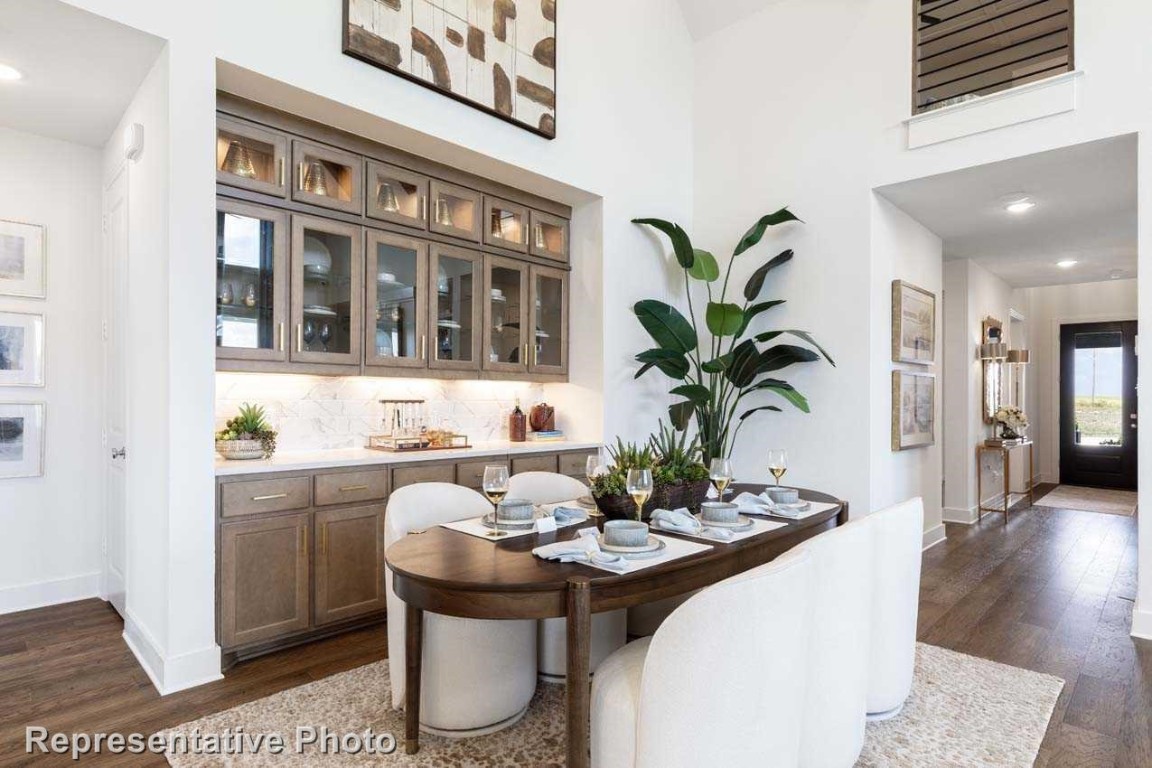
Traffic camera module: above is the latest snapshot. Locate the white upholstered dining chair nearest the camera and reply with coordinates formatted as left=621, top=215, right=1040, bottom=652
left=592, top=552, right=815, bottom=768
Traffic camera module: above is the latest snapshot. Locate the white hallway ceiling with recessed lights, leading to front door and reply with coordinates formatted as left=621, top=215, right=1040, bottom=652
left=877, top=136, right=1137, bottom=288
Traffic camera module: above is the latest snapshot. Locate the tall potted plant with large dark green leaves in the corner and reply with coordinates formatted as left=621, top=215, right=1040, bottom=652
left=632, top=208, right=835, bottom=464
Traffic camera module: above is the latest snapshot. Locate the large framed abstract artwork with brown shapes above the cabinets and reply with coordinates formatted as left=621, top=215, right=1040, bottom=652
left=343, top=0, right=556, bottom=138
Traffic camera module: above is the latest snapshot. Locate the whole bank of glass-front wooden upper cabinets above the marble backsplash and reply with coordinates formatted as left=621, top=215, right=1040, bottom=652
left=217, top=97, right=569, bottom=381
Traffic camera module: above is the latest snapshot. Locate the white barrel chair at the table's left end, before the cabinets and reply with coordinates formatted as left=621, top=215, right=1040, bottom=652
left=384, top=482, right=536, bottom=737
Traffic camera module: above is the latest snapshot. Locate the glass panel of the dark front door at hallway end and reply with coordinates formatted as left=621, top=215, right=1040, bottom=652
left=1074, top=330, right=1124, bottom=446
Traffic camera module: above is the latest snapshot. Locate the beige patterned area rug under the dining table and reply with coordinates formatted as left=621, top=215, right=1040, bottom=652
left=167, top=644, right=1063, bottom=768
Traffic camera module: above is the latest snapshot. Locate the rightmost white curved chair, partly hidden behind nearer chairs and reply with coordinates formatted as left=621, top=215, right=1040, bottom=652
left=862, top=497, right=924, bottom=720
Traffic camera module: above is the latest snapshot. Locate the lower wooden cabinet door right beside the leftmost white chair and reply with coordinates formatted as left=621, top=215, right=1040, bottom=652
left=316, top=504, right=385, bottom=625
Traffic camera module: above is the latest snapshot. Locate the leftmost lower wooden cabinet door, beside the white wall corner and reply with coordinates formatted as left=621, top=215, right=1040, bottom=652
left=220, top=512, right=311, bottom=648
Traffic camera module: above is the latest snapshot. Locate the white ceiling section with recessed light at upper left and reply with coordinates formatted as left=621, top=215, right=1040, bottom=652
left=0, top=0, right=164, bottom=146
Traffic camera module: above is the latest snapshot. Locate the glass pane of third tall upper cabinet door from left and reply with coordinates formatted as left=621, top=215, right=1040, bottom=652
left=370, top=243, right=419, bottom=358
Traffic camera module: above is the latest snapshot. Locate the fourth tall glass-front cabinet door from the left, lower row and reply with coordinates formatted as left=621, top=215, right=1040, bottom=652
left=427, top=244, right=484, bottom=371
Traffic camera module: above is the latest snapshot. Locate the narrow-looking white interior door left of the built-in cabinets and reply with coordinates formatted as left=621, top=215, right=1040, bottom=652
left=103, top=166, right=128, bottom=616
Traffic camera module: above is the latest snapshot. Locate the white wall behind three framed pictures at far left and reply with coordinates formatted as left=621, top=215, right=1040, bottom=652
left=0, top=128, right=103, bottom=614
